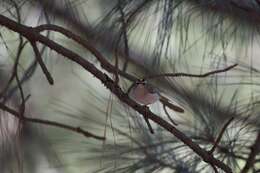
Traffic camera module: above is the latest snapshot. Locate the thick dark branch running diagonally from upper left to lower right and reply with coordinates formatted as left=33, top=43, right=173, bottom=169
left=0, top=15, right=232, bottom=173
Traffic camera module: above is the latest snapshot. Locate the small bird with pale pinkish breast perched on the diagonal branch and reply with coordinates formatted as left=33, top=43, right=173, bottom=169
left=128, top=80, right=184, bottom=113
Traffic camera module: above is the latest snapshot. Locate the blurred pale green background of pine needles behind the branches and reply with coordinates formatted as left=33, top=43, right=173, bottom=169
left=0, top=0, right=260, bottom=173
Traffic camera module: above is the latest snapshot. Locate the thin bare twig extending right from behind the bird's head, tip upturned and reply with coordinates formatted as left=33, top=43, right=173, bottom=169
left=143, top=64, right=238, bottom=80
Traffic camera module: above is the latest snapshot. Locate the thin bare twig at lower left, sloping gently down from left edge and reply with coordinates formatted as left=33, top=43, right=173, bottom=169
left=0, top=103, right=105, bottom=140
